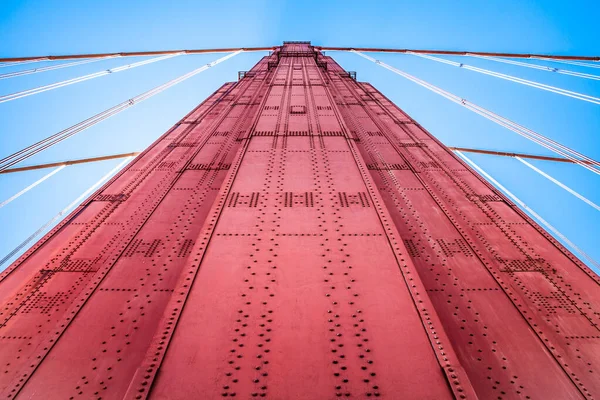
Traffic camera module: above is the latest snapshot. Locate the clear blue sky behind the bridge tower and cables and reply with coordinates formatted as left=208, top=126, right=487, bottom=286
left=0, top=0, right=600, bottom=269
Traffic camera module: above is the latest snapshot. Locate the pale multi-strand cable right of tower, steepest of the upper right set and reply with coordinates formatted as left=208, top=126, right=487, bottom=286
left=351, top=50, right=600, bottom=175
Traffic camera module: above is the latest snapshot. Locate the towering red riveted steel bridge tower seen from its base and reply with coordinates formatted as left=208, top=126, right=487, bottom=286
left=0, top=42, right=600, bottom=399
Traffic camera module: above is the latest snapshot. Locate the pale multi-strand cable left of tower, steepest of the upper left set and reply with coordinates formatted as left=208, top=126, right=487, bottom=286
left=0, top=50, right=243, bottom=171
